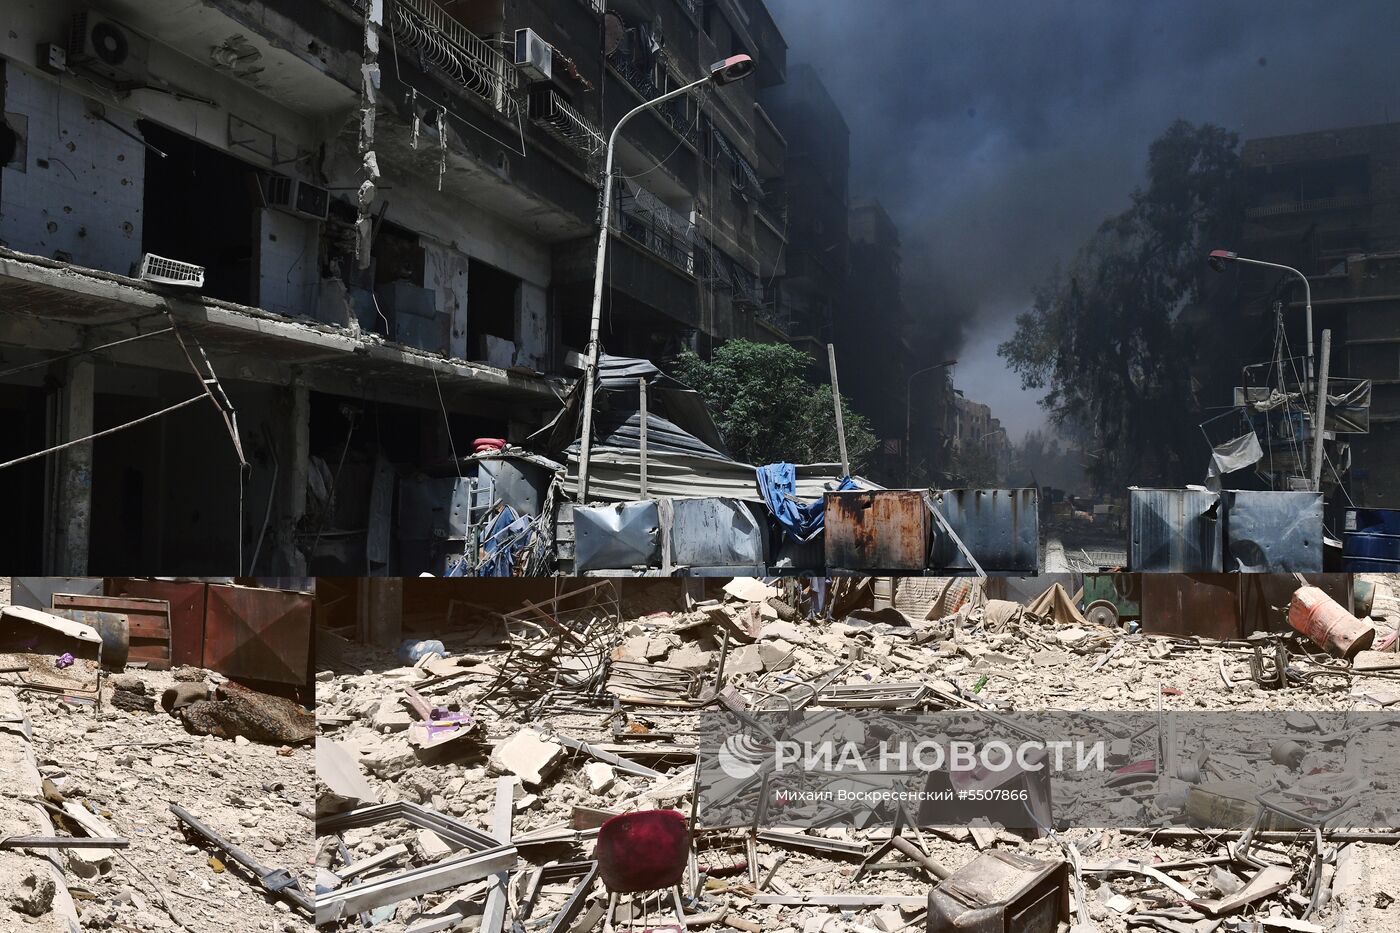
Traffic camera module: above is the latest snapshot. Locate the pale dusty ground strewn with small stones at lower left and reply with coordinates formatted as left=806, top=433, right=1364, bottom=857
left=0, top=591, right=314, bottom=933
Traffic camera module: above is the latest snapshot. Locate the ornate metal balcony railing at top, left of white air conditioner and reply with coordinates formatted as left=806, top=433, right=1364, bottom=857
left=391, top=0, right=519, bottom=116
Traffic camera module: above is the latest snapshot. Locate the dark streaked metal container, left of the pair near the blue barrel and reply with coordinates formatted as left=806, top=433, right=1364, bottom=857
left=1128, top=488, right=1224, bottom=573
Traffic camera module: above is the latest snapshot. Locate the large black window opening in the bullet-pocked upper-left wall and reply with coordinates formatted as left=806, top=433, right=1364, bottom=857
left=137, top=120, right=260, bottom=304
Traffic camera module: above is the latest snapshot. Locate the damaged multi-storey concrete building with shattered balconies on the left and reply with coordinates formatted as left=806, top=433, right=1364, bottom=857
left=0, top=0, right=787, bottom=574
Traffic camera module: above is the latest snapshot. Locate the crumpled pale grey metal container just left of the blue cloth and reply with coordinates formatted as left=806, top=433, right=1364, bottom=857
left=658, top=499, right=769, bottom=573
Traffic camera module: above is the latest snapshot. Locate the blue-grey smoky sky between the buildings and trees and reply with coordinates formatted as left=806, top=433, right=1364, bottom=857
left=767, top=0, right=1400, bottom=438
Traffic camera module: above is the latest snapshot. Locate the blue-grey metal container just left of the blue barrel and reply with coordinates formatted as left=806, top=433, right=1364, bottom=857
left=1221, top=489, right=1323, bottom=573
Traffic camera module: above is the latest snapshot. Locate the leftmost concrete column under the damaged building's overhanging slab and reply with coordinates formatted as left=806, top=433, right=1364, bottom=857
left=50, top=360, right=94, bottom=577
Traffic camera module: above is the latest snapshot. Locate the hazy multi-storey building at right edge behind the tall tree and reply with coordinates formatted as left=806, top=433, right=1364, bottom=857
left=1238, top=123, right=1400, bottom=509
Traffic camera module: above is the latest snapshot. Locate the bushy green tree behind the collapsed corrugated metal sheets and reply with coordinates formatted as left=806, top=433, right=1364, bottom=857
left=671, top=340, right=876, bottom=472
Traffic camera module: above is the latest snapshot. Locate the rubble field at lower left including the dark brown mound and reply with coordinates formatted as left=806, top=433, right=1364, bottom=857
left=0, top=591, right=314, bottom=933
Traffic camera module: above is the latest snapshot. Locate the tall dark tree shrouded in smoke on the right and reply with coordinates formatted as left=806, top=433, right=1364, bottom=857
left=997, top=120, right=1243, bottom=489
